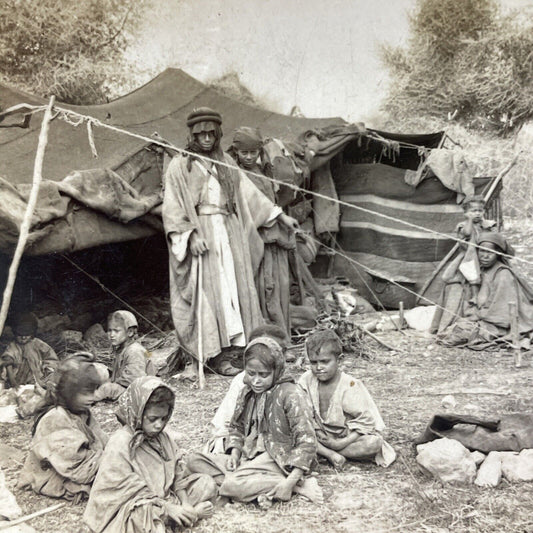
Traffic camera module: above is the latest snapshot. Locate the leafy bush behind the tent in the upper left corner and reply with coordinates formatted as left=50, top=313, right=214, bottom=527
left=0, top=0, right=148, bottom=104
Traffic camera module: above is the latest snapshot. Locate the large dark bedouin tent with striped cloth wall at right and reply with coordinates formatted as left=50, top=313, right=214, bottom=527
left=0, top=69, right=496, bottom=314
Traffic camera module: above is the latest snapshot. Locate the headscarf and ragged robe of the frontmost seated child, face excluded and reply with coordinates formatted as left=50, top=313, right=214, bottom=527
left=83, top=376, right=215, bottom=533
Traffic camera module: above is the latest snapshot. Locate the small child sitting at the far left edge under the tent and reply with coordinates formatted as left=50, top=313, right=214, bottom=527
left=1, top=313, right=58, bottom=390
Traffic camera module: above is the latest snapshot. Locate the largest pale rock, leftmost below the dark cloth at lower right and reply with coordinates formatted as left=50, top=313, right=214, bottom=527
left=416, top=439, right=477, bottom=484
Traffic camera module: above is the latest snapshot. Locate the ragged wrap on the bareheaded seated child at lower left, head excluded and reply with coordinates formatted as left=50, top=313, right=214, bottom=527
left=19, top=406, right=107, bottom=500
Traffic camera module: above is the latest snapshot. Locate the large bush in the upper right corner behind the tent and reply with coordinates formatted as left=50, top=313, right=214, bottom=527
left=382, top=0, right=533, bottom=133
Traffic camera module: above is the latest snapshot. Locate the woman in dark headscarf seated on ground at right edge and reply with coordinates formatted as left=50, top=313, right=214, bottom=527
left=439, top=232, right=533, bottom=349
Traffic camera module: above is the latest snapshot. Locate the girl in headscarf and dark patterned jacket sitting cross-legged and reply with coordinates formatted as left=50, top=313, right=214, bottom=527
left=188, top=337, right=322, bottom=506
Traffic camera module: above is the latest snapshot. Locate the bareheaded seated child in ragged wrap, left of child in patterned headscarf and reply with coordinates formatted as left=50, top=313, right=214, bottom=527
left=19, top=354, right=107, bottom=502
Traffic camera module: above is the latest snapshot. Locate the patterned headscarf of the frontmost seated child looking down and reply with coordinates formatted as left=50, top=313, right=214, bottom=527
left=117, top=376, right=175, bottom=457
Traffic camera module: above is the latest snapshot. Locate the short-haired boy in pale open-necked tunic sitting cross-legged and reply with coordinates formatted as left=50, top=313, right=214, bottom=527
left=299, top=330, right=396, bottom=468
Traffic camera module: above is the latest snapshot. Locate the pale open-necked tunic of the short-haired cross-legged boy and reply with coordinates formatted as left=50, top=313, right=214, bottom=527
left=298, top=370, right=396, bottom=466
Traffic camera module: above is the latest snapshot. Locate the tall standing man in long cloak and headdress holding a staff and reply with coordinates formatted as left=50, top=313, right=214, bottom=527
left=163, top=107, right=298, bottom=374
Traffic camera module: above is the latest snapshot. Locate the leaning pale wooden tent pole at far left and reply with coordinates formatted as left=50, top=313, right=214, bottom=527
left=0, top=96, right=55, bottom=335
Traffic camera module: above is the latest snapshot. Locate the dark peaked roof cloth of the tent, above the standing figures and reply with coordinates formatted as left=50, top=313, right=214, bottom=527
left=0, top=69, right=345, bottom=184
